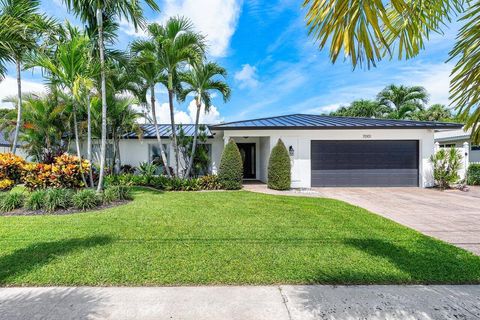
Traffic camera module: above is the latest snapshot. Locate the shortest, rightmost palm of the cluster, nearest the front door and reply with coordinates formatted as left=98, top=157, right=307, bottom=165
left=179, top=62, right=231, bottom=177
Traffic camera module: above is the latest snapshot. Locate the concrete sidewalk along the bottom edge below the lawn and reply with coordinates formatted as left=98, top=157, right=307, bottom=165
left=0, top=286, right=480, bottom=320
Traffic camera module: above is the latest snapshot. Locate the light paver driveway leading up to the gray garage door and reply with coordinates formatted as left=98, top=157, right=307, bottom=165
left=245, top=184, right=480, bottom=255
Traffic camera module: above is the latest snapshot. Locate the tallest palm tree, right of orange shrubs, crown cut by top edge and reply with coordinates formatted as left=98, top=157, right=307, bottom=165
left=63, top=0, right=159, bottom=192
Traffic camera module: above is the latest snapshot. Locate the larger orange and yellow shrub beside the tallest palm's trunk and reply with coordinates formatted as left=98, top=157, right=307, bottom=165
left=23, top=153, right=90, bottom=190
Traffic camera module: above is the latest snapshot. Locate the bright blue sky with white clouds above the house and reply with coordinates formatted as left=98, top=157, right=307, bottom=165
left=0, top=0, right=458, bottom=123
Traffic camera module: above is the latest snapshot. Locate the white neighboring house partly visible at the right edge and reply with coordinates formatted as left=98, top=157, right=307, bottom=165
left=435, top=128, right=480, bottom=162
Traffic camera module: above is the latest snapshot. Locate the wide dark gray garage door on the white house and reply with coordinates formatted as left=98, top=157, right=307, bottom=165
left=311, top=140, right=418, bottom=187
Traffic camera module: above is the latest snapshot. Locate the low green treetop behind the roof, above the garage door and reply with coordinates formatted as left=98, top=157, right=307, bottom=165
left=330, top=99, right=392, bottom=118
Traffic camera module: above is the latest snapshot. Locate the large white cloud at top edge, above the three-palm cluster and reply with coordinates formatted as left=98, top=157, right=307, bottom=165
left=135, top=0, right=243, bottom=57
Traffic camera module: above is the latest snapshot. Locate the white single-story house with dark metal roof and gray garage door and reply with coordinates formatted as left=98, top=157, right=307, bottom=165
left=114, top=114, right=462, bottom=188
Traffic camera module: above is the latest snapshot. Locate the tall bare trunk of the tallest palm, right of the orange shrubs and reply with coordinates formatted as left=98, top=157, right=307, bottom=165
left=97, top=7, right=107, bottom=192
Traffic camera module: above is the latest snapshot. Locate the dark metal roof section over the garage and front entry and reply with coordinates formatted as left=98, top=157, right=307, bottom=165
left=210, top=114, right=463, bottom=130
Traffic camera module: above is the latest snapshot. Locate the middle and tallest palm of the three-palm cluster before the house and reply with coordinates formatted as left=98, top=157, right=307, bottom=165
left=148, top=17, right=205, bottom=176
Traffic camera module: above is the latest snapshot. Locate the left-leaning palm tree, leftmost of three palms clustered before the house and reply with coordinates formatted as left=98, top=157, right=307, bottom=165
left=131, top=40, right=171, bottom=177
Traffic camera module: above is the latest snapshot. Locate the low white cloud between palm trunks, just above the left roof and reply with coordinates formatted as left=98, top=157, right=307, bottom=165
left=153, top=100, right=223, bottom=124
